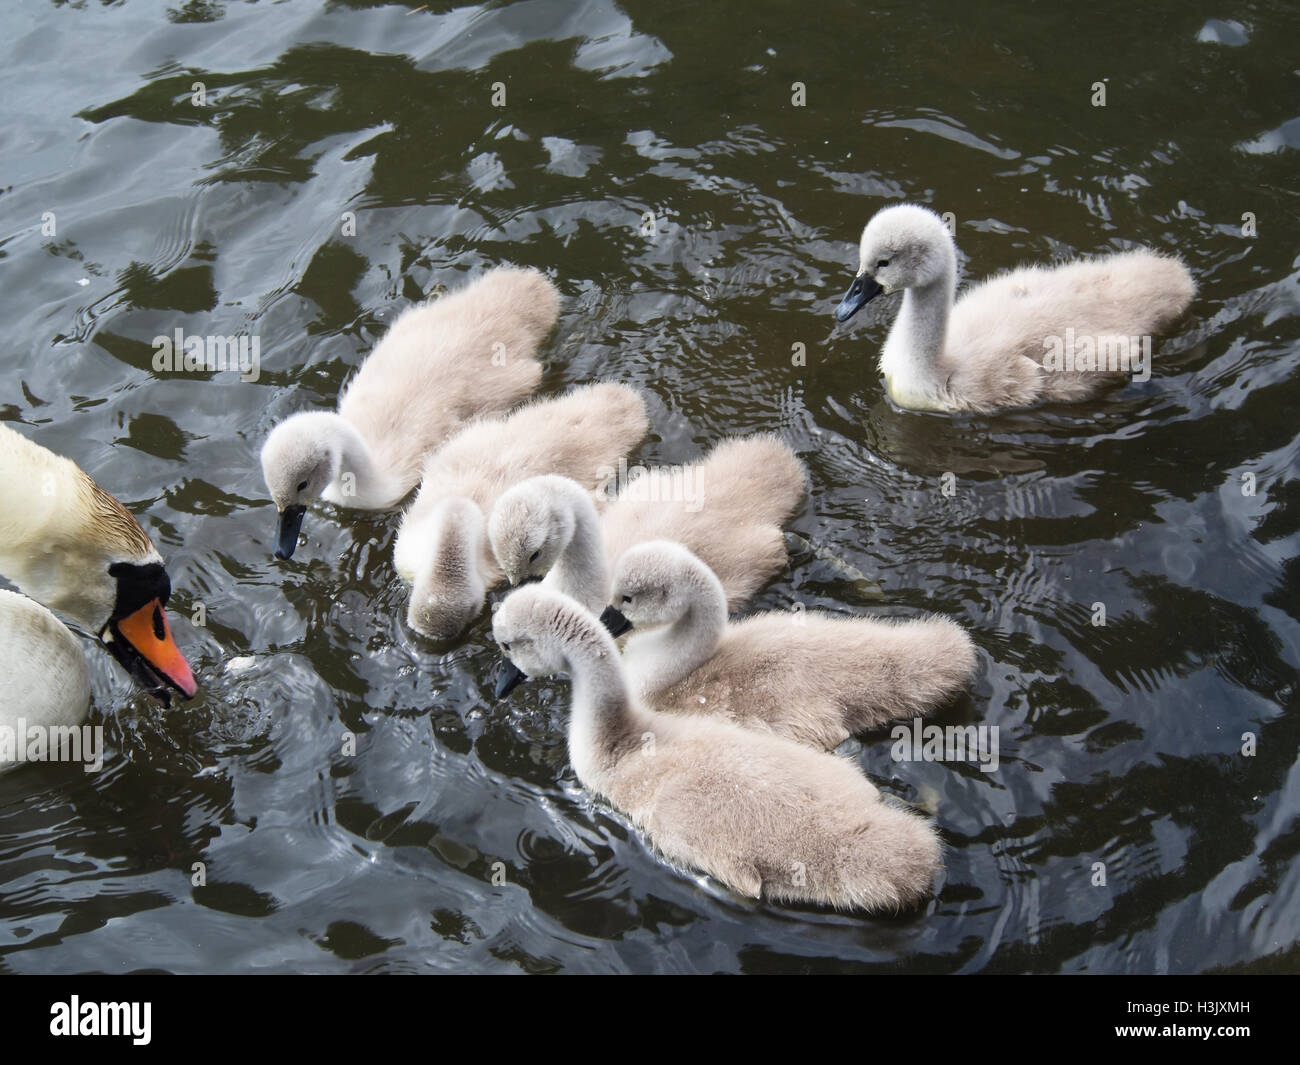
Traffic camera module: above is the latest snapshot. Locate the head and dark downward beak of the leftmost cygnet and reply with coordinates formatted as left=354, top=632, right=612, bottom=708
left=261, top=411, right=343, bottom=558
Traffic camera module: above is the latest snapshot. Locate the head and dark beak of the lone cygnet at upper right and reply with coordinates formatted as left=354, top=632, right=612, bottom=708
left=835, top=203, right=957, bottom=321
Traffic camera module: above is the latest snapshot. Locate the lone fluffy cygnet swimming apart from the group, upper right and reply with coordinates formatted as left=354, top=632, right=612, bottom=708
left=836, top=204, right=1196, bottom=412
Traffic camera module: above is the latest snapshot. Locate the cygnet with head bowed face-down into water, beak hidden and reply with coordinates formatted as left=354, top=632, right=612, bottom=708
left=393, top=384, right=650, bottom=640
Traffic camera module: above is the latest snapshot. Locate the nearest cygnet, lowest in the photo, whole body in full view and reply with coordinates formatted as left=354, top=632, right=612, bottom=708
left=493, top=585, right=941, bottom=910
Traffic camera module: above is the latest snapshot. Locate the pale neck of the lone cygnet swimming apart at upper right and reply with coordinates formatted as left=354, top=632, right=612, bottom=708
left=880, top=254, right=957, bottom=410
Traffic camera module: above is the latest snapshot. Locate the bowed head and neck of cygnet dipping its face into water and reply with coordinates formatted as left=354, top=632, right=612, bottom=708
left=402, top=497, right=488, bottom=640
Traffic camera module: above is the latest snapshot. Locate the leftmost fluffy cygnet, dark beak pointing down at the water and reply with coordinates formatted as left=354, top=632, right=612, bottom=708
left=261, top=267, right=559, bottom=558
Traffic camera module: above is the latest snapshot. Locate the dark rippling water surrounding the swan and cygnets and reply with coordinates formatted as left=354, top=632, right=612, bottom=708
left=0, top=0, right=1300, bottom=973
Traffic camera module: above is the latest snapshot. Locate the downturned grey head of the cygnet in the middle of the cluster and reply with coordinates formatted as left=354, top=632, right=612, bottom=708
left=488, top=475, right=582, bottom=585
